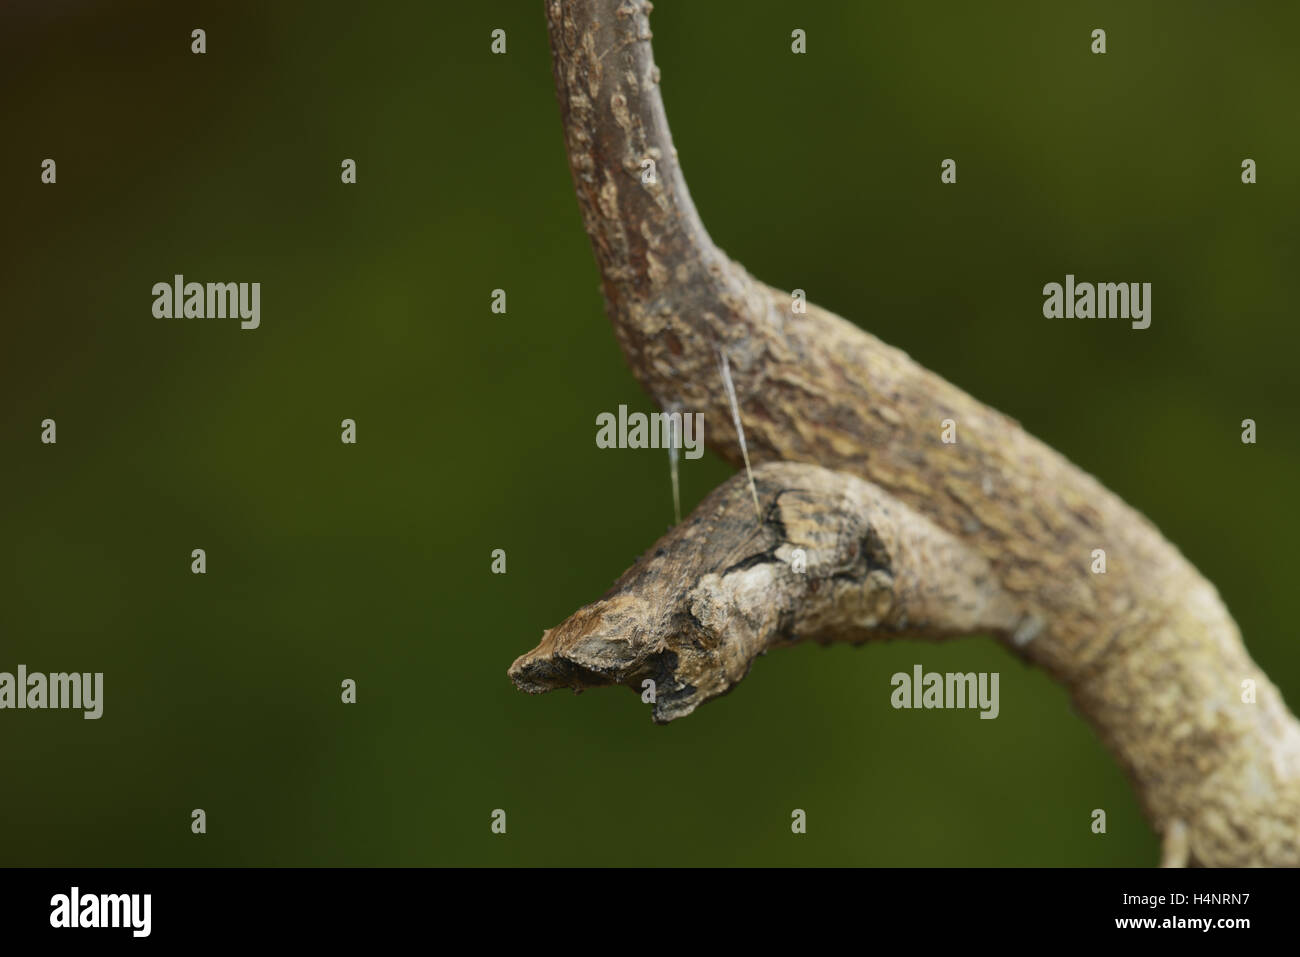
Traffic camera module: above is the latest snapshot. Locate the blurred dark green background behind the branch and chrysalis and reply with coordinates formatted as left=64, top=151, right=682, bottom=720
left=0, top=0, right=1300, bottom=865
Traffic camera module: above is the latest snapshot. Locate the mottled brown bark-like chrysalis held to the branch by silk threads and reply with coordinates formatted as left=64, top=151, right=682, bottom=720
left=510, top=463, right=1022, bottom=722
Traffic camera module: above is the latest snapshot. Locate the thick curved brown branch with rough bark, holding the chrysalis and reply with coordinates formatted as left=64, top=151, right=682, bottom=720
left=516, top=0, right=1300, bottom=865
